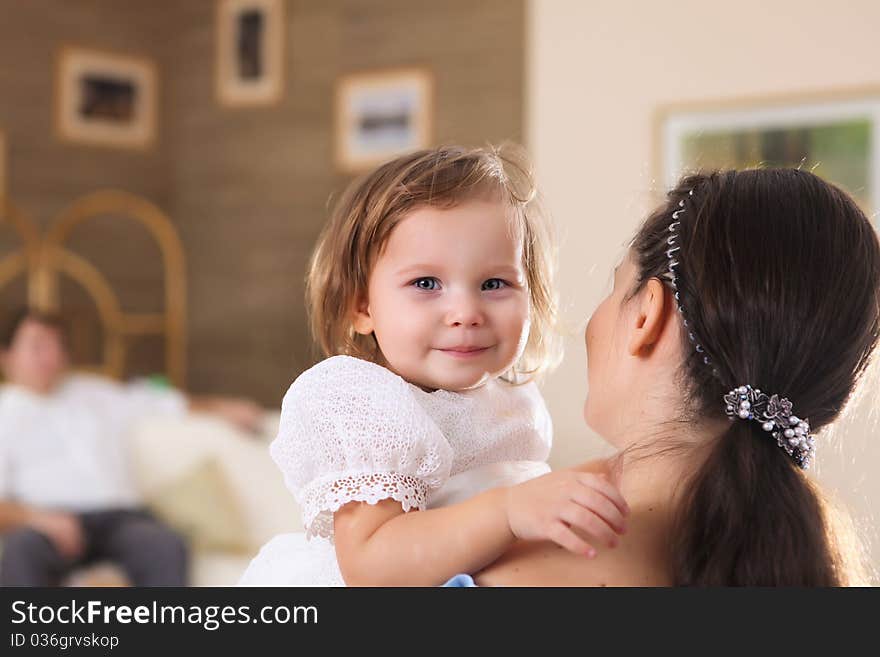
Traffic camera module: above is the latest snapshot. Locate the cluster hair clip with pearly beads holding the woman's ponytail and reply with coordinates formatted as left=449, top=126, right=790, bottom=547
left=724, top=385, right=816, bottom=470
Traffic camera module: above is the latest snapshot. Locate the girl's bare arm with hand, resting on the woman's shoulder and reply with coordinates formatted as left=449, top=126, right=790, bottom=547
left=334, top=470, right=629, bottom=586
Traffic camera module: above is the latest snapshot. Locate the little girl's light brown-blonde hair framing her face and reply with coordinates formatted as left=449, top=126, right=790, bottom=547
left=306, top=145, right=559, bottom=381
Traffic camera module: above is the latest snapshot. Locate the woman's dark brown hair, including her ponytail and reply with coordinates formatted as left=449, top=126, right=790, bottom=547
left=633, top=169, right=880, bottom=586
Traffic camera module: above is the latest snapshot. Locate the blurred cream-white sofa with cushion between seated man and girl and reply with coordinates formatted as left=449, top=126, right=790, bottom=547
left=131, top=413, right=301, bottom=586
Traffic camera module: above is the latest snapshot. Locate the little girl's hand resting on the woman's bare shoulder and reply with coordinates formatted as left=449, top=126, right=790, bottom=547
left=507, top=468, right=629, bottom=557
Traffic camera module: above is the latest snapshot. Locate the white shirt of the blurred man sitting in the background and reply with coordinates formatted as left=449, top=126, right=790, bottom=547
left=0, top=374, right=186, bottom=512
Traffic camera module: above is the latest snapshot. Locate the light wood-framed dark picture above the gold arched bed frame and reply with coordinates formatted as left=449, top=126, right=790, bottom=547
left=55, top=48, right=158, bottom=148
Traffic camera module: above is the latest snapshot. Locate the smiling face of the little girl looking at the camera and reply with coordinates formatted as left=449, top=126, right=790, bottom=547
left=355, top=195, right=529, bottom=390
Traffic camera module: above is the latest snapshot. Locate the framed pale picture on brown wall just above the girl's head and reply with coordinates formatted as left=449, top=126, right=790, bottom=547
left=335, top=69, right=433, bottom=173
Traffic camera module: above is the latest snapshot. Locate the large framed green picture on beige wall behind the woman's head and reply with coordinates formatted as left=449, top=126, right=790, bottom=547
left=657, top=89, right=880, bottom=220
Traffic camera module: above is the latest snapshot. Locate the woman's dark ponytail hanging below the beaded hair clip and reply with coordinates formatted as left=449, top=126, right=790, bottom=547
left=669, top=420, right=845, bottom=586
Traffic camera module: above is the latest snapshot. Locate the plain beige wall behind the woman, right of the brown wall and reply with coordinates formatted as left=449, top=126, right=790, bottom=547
left=526, top=0, right=880, bottom=576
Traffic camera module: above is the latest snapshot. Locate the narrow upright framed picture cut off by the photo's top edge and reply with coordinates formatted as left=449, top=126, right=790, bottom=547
left=215, top=0, right=284, bottom=107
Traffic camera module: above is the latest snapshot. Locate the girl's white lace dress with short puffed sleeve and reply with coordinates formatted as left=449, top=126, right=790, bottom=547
left=239, top=356, right=552, bottom=586
